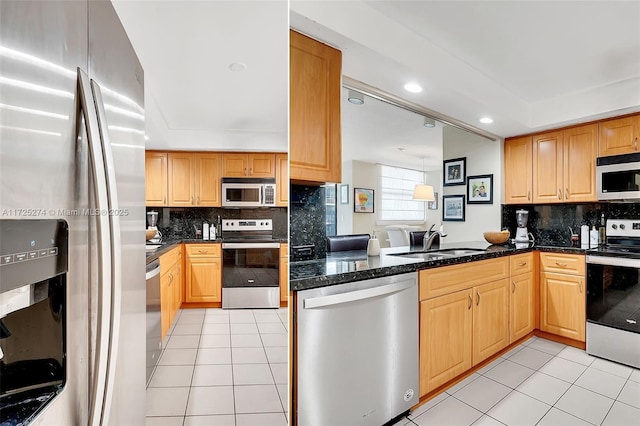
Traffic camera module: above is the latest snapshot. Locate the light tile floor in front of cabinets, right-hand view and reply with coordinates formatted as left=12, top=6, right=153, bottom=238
left=395, top=337, right=640, bottom=426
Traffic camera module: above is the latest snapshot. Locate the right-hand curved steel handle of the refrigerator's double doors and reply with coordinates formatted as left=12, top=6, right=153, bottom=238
left=91, top=80, right=122, bottom=424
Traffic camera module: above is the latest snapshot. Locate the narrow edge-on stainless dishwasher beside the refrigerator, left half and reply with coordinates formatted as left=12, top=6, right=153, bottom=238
left=146, top=260, right=162, bottom=385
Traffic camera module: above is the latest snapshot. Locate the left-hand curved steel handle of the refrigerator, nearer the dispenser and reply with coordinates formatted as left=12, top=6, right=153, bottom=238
left=78, top=68, right=112, bottom=426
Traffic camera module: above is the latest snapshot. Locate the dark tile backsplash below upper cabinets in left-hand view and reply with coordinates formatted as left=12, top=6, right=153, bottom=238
left=147, top=207, right=288, bottom=240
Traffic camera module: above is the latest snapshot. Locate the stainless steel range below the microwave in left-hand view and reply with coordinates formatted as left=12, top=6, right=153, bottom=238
left=222, top=219, right=280, bottom=309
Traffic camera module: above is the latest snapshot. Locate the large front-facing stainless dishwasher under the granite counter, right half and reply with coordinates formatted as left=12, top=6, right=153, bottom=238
left=296, top=273, right=419, bottom=426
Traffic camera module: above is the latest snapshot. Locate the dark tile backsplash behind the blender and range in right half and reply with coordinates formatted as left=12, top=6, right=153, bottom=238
left=502, top=203, right=640, bottom=246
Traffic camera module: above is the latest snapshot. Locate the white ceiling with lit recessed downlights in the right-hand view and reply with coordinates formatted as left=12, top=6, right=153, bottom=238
left=290, top=0, right=640, bottom=137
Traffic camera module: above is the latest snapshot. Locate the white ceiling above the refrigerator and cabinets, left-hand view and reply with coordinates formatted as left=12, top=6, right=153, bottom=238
left=113, top=0, right=289, bottom=151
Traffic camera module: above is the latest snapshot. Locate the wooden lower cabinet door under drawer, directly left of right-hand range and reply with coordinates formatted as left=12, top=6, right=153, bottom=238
left=540, top=272, right=586, bottom=342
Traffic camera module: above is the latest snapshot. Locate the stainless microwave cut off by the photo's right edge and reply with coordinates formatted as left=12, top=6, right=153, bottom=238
left=596, top=153, right=640, bottom=201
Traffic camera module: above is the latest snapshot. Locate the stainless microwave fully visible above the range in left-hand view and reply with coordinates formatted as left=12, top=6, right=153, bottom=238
left=222, top=178, right=276, bottom=207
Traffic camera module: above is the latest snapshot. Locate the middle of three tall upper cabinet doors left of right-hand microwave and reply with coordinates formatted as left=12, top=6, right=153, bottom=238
left=533, top=132, right=564, bottom=203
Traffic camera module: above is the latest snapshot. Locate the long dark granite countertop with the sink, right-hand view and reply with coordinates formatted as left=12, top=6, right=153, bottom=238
left=289, top=241, right=586, bottom=291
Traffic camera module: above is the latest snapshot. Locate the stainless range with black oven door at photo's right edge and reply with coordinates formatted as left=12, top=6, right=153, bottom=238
left=586, top=219, right=640, bottom=368
